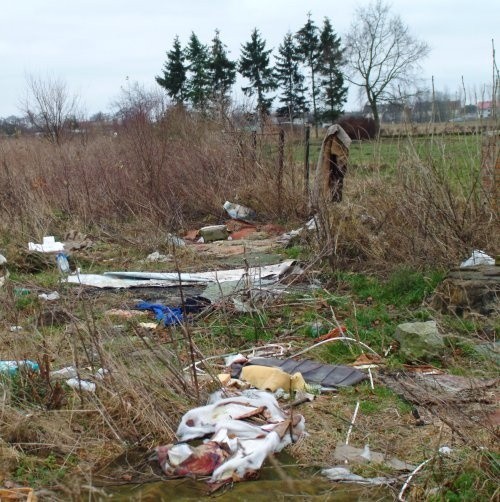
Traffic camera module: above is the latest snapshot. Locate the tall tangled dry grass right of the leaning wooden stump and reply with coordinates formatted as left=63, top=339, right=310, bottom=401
left=312, top=131, right=500, bottom=270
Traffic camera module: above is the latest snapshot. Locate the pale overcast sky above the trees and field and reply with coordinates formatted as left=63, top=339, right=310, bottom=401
left=0, top=0, right=500, bottom=117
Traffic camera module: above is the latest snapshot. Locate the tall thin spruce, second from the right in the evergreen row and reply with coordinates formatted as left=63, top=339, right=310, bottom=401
left=296, top=12, right=320, bottom=137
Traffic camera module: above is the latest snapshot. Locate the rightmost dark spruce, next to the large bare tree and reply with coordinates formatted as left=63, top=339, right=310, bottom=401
left=318, top=17, right=347, bottom=123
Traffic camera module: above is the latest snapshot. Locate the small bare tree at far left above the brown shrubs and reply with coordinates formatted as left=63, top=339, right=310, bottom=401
left=22, top=75, right=80, bottom=145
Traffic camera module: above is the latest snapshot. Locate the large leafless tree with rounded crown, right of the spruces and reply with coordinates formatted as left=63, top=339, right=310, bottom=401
left=345, top=0, right=430, bottom=135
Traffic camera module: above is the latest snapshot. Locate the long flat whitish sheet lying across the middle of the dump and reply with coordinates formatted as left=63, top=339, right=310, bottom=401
left=66, top=260, right=295, bottom=288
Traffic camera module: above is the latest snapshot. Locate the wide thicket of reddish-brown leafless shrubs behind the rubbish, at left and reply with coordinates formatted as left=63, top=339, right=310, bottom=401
left=0, top=110, right=305, bottom=238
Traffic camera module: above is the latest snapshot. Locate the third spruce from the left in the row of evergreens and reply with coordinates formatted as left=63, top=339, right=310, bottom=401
left=209, top=30, right=236, bottom=112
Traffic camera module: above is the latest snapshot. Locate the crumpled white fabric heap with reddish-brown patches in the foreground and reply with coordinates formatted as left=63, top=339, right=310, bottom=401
left=157, top=390, right=305, bottom=485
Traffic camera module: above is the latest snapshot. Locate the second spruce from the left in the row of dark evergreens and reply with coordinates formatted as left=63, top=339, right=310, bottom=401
left=185, top=32, right=210, bottom=112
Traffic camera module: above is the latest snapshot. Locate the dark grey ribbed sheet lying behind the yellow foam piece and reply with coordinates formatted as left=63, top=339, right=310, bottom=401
left=231, top=357, right=368, bottom=388
